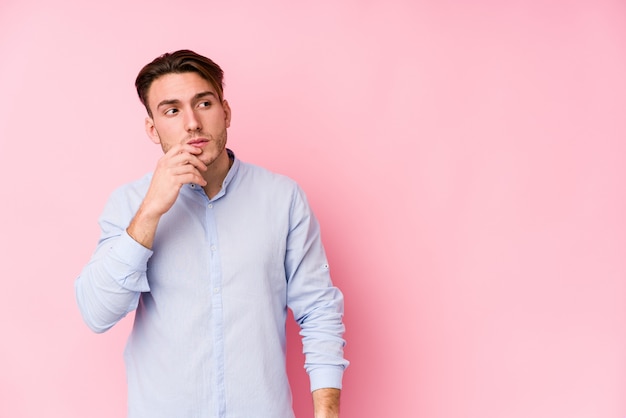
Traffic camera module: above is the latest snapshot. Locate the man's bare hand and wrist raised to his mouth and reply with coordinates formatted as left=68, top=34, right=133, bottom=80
left=126, top=144, right=207, bottom=248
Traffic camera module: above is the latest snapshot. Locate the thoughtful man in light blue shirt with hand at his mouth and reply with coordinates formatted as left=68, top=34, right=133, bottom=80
left=76, top=50, right=348, bottom=418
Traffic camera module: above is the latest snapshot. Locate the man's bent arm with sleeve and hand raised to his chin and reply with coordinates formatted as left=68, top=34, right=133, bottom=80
left=75, top=145, right=206, bottom=333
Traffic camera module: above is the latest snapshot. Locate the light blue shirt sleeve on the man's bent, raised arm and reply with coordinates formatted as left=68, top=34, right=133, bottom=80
left=74, top=186, right=152, bottom=333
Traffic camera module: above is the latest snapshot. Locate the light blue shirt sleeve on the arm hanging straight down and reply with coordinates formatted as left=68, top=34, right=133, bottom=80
left=285, top=187, right=349, bottom=391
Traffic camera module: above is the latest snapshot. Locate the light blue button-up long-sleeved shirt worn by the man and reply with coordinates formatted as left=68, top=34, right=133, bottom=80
left=75, top=151, right=348, bottom=418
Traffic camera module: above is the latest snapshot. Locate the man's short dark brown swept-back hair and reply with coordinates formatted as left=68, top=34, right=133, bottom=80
left=135, top=49, right=224, bottom=116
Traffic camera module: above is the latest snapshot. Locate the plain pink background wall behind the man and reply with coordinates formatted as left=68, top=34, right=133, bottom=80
left=0, top=0, right=626, bottom=418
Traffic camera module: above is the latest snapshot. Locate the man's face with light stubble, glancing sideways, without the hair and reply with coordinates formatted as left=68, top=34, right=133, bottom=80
left=146, top=72, right=230, bottom=166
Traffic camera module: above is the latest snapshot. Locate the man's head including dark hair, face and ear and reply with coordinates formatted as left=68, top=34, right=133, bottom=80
left=135, top=50, right=231, bottom=171
